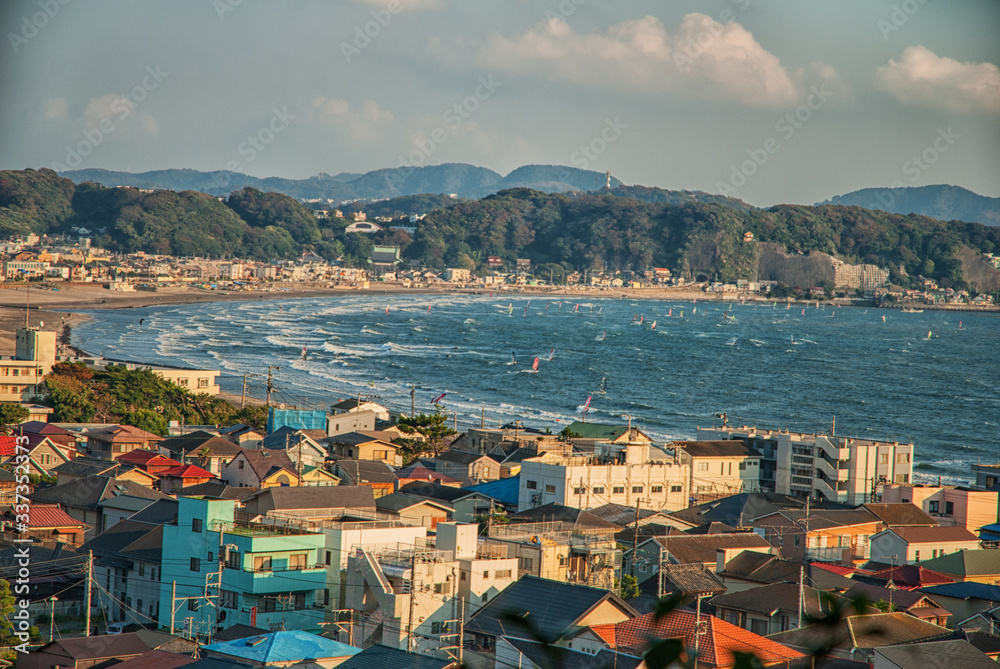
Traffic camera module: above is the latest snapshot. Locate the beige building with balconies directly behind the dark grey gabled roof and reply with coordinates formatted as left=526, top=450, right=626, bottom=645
left=480, top=521, right=621, bottom=588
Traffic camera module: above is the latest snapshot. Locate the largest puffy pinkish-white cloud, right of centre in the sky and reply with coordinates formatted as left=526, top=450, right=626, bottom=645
left=468, top=13, right=837, bottom=107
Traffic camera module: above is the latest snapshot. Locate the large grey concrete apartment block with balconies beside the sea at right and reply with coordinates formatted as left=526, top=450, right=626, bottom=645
left=697, top=426, right=913, bottom=504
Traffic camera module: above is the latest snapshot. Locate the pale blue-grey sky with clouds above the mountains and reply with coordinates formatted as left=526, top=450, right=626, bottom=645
left=0, top=0, right=1000, bottom=206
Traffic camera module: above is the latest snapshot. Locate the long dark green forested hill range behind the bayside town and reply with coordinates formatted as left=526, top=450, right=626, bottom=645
left=0, top=170, right=1000, bottom=287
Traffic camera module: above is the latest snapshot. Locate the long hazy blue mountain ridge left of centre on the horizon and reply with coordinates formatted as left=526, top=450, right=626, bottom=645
left=60, top=163, right=621, bottom=202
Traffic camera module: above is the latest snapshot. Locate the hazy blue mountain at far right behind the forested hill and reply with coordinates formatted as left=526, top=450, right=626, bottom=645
left=817, top=184, right=1000, bottom=225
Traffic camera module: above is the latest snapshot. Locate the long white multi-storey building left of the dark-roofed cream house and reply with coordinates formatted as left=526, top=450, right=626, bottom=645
left=517, top=443, right=690, bottom=511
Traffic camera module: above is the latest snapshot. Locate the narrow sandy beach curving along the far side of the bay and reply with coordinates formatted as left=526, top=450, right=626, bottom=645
left=0, top=284, right=1000, bottom=355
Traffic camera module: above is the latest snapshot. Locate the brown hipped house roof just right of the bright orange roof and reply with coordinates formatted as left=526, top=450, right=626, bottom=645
left=769, top=611, right=948, bottom=662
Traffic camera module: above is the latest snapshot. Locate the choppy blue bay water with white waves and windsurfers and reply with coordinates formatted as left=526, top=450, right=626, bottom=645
left=73, top=294, right=1000, bottom=483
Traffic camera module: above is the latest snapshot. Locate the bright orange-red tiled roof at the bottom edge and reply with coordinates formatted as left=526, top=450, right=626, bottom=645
left=602, top=610, right=804, bottom=667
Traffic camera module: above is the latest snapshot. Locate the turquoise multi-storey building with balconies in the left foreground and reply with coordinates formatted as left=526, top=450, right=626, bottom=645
left=158, top=497, right=327, bottom=636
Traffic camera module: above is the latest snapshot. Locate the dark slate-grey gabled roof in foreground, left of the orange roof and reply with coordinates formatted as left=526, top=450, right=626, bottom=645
left=465, top=575, right=638, bottom=641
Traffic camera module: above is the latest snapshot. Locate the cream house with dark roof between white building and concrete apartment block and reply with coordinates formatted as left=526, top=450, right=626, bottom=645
left=667, top=439, right=760, bottom=504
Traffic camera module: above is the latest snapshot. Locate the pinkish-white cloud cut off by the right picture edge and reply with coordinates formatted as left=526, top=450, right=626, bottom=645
left=875, top=46, right=1000, bottom=114
